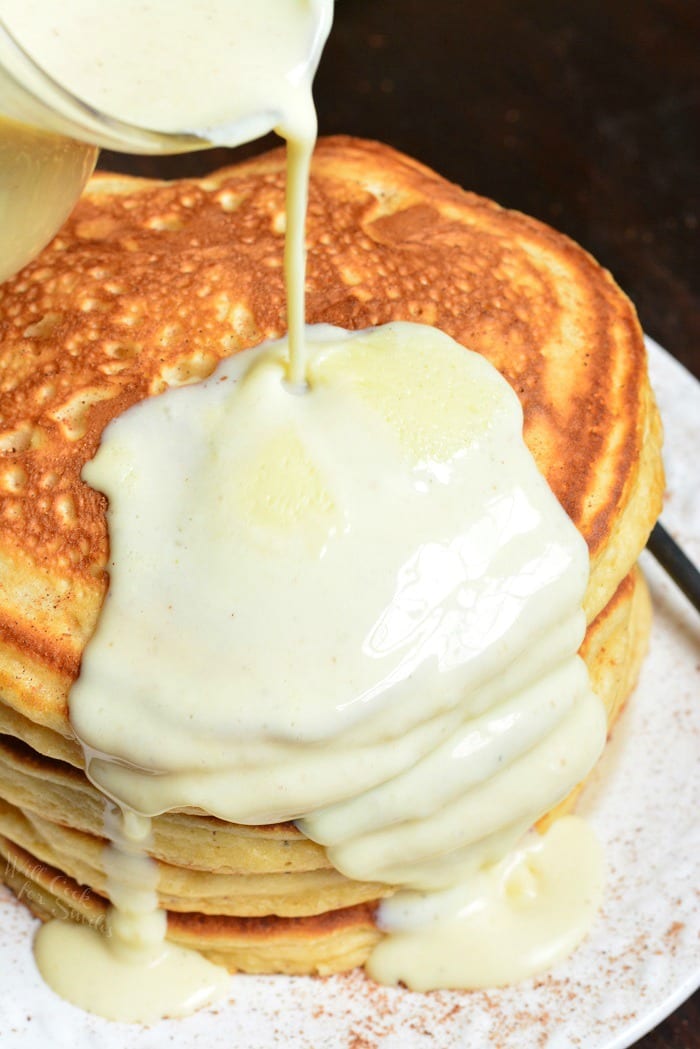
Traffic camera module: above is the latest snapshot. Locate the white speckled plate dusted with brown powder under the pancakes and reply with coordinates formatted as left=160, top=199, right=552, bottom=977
left=0, top=343, right=700, bottom=1049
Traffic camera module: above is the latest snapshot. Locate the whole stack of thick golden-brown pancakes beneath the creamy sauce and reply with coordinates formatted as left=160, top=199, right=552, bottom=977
left=0, top=137, right=663, bottom=972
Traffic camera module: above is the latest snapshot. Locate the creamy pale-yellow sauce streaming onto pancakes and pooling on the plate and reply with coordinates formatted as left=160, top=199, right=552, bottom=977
left=16, top=3, right=606, bottom=1021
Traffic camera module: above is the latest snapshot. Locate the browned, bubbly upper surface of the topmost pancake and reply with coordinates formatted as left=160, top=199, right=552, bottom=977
left=0, top=137, right=660, bottom=723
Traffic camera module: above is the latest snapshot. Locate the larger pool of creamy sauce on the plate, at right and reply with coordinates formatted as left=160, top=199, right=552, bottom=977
left=366, top=816, right=603, bottom=991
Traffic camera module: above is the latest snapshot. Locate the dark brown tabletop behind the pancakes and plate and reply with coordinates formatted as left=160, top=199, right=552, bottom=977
left=102, top=0, right=700, bottom=1049
